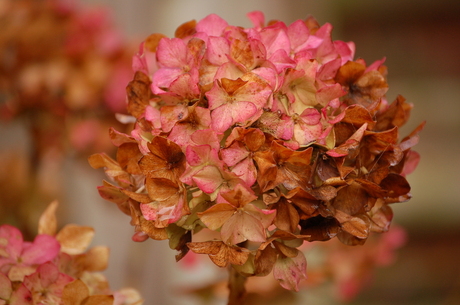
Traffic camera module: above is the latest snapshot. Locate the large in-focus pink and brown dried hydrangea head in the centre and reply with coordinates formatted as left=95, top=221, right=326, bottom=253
left=89, top=12, right=423, bottom=290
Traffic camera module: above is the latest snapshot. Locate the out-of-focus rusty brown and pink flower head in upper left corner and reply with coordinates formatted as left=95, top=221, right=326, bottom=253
left=0, top=0, right=135, bottom=154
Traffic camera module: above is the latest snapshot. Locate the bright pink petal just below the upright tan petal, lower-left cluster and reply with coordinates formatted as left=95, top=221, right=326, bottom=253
left=21, top=234, right=61, bottom=265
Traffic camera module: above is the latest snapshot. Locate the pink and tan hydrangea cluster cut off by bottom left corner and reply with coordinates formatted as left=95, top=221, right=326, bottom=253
left=0, top=201, right=142, bottom=305
